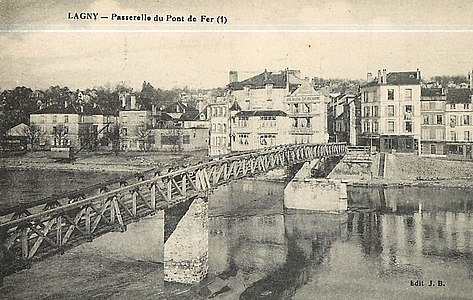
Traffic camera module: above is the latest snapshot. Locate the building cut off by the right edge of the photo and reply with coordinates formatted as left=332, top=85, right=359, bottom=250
left=445, top=88, right=473, bottom=159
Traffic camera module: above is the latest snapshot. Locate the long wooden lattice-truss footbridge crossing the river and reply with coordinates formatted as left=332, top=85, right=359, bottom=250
left=0, top=143, right=346, bottom=268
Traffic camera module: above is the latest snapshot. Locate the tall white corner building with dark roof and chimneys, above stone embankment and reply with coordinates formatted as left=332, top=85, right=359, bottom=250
left=361, top=69, right=421, bottom=152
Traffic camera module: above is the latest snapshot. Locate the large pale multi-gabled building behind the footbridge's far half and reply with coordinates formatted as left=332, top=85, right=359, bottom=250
left=208, top=69, right=328, bottom=155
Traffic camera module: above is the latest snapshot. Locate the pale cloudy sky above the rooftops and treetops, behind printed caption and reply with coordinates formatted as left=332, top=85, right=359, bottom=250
left=0, top=0, right=473, bottom=90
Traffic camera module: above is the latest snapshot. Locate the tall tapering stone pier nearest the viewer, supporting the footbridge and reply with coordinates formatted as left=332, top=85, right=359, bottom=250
left=164, top=197, right=209, bottom=284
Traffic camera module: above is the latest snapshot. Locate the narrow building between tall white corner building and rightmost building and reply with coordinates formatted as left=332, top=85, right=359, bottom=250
left=420, top=88, right=447, bottom=156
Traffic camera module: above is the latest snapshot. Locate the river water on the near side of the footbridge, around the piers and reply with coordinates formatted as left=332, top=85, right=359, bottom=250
left=0, top=170, right=473, bottom=299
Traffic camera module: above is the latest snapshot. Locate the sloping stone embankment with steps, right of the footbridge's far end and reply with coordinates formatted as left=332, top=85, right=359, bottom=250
left=330, top=154, right=473, bottom=188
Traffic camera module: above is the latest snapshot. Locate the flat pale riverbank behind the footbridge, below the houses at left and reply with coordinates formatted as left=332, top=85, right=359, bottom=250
left=0, top=151, right=207, bottom=172
